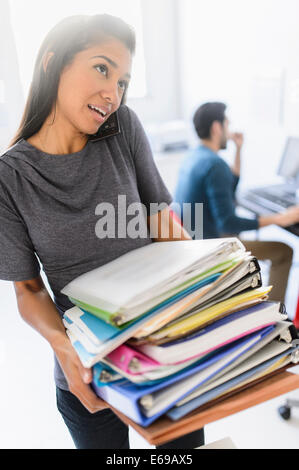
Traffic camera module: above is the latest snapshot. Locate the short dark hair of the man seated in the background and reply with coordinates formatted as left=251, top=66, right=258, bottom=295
left=193, top=102, right=226, bottom=139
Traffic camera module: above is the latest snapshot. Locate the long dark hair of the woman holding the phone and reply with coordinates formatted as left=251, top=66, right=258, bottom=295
left=10, top=14, right=136, bottom=146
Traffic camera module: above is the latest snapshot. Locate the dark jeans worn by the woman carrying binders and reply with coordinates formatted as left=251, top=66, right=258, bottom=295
left=56, top=387, right=204, bottom=449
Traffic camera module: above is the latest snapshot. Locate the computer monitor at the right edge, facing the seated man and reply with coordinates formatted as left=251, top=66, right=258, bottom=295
left=278, top=137, right=299, bottom=186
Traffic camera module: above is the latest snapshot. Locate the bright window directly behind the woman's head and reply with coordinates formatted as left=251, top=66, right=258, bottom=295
left=10, top=0, right=146, bottom=98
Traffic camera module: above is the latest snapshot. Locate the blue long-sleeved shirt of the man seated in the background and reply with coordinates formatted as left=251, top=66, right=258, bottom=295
left=174, top=145, right=258, bottom=238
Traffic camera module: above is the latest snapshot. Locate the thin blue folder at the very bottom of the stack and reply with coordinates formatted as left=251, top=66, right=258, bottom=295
left=166, top=347, right=298, bottom=421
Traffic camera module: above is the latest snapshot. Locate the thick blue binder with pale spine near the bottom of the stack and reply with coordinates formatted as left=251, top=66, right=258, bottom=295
left=92, top=326, right=273, bottom=427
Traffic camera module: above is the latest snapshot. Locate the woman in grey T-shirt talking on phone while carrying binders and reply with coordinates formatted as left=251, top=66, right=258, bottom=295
left=0, top=15, right=203, bottom=448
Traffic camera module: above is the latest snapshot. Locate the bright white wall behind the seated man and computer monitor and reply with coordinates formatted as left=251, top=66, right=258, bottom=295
left=178, top=0, right=299, bottom=185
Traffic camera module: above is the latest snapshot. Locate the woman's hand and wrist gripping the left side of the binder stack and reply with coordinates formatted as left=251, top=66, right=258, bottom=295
left=52, top=335, right=109, bottom=413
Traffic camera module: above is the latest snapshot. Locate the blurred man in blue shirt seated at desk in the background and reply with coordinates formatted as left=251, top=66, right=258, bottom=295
left=174, top=102, right=299, bottom=301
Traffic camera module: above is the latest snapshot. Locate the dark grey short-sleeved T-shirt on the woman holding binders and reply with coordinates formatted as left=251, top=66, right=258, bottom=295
left=0, top=105, right=171, bottom=389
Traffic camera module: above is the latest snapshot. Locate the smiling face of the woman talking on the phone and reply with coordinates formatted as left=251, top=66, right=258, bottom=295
left=55, top=39, right=132, bottom=134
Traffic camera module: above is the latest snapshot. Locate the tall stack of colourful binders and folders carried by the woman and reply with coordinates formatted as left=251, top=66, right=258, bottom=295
left=62, top=238, right=299, bottom=426
